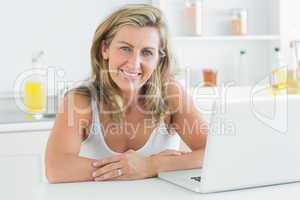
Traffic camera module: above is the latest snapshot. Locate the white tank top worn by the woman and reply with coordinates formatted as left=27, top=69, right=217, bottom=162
left=79, top=98, right=180, bottom=160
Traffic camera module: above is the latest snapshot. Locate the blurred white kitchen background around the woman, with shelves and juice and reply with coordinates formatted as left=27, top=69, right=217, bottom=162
left=0, top=0, right=300, bottom=139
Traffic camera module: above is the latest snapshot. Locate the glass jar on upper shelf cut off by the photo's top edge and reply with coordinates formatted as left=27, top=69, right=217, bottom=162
left=185, top=0, right=203, bottom=36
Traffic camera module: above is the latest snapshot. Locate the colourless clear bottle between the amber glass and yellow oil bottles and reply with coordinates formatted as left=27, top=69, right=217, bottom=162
left=236, top=49, right=249, bottom=86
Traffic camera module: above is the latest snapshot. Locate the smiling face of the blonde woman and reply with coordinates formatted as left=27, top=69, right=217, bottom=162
left=101, top=25, right=160, bottom=92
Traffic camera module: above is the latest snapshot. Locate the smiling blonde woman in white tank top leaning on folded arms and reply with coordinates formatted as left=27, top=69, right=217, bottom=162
left=46, top=5, right=207, bottom=183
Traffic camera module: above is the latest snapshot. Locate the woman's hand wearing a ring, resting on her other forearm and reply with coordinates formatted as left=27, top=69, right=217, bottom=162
left=92, top=150, right=156, bottom=181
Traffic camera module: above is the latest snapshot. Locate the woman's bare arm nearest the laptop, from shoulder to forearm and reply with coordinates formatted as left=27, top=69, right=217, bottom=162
left=151, top=81, right=208, bottom=175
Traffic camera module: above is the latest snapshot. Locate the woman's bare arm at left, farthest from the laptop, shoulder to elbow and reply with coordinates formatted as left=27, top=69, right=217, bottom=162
left=45, top=92, right=95, bottom=183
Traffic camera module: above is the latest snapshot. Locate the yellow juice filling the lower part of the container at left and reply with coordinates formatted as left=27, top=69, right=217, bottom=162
left=24, top=81, right=46, bottom=115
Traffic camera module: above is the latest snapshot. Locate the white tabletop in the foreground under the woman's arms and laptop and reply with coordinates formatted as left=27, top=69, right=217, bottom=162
left=31, top=178, right=300, bottom=200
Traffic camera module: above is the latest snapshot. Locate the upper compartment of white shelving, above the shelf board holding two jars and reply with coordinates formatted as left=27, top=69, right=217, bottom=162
left=152, top=0, right=281, bottom=36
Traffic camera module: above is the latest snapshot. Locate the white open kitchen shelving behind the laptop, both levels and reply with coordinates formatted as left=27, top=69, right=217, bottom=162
left=152, top=0, right=300, bottom=86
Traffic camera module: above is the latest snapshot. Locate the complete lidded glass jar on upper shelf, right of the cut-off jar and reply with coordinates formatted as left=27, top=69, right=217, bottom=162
left=231, top=8, right=248, bottom=35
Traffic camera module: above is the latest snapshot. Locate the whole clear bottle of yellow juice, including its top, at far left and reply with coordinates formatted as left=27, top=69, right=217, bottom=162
left=24, top=51, right=46, bottom=118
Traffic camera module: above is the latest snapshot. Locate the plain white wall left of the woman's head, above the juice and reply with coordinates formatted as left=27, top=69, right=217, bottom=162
left=0, top=0, right=151, bottom=93
